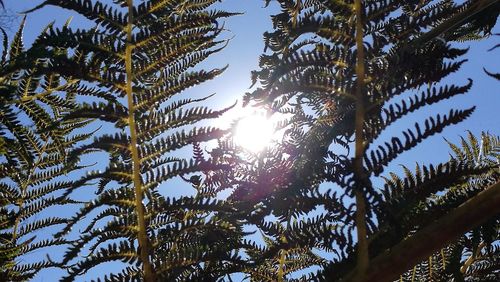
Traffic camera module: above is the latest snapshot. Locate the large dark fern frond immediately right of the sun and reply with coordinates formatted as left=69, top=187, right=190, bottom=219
left=214, top=0, right=499, bottom=281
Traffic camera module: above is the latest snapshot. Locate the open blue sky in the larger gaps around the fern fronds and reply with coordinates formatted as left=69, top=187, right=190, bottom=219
left=4, top=0, right=500, bottom=281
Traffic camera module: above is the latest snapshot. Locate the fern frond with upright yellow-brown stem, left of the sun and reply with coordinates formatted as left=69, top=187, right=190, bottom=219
left=27, top=0, right=246, bottom=281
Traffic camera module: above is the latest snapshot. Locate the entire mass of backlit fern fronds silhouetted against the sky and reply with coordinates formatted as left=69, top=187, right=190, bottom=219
left=0, top=0, right=500, bottom=282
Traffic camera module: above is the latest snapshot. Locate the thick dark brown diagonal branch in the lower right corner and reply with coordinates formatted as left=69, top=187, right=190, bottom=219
left=343, top=181, right=500, bottom=282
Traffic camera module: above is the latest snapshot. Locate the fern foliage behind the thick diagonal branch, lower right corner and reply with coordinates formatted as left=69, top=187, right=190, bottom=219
left=398, top=133, right=500, bottom=281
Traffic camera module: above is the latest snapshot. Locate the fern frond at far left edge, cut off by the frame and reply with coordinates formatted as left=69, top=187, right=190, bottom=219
left=0, top=21, right=90, bottom=281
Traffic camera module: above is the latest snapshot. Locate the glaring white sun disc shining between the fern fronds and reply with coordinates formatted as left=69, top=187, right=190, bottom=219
left=234, top=114, right=274, bottom=153
